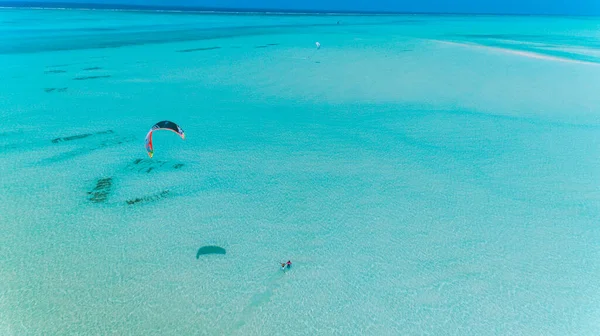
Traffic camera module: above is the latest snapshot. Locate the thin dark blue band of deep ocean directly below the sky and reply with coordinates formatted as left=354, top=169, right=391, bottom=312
left=0, top=1, right=599, bottom=17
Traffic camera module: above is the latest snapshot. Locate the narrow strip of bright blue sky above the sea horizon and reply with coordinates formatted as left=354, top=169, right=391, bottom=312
left=8, top=0, right=600, bottom=15
